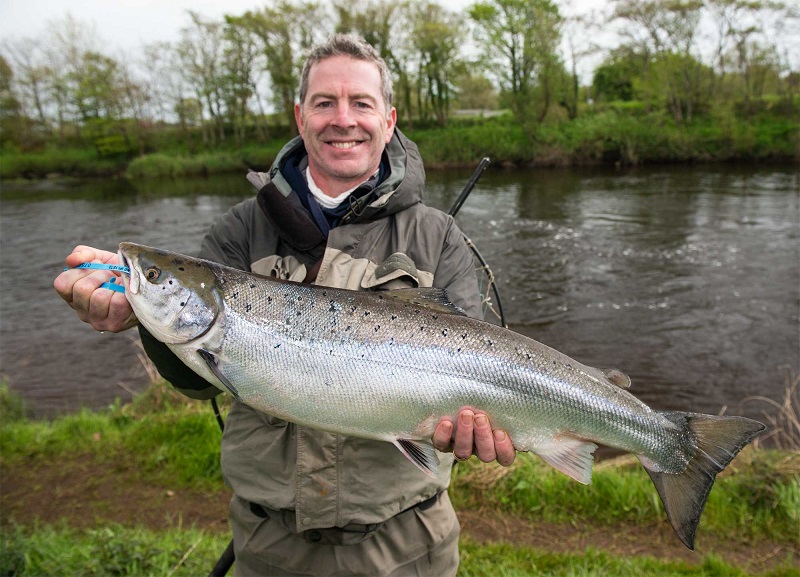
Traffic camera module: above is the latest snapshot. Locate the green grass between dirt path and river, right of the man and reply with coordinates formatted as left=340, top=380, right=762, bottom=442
left=451, top=449, right=800, bottom=543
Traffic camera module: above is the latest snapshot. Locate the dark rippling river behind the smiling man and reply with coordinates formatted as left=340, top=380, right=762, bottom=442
left=0, top=165, right=800, bottom=418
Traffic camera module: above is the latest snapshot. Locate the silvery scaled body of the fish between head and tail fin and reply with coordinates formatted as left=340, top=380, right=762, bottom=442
left=214, top=260, right=686, bottom=470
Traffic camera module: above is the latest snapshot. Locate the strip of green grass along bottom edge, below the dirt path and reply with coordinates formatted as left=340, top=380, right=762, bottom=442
left=0, top=525, right=800, bottom=577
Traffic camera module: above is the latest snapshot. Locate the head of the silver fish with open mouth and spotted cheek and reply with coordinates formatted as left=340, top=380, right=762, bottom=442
left=119, top=242, right=221, bottom=344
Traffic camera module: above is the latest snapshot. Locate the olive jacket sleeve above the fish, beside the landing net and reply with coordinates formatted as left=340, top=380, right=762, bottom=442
left=433, top=217, right=483, bottom=319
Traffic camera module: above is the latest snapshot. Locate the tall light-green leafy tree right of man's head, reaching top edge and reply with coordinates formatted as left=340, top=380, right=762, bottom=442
left=469, top=0, right=561, bottom=140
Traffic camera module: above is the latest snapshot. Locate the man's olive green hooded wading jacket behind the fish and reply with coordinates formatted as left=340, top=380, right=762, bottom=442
left=140, top=132, right=480, bottom=532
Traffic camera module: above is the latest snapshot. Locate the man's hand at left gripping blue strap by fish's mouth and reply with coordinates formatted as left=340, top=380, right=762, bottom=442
left=53, top=245, right=138, bottom=333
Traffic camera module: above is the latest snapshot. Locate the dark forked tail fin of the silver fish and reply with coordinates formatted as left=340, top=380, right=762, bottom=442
left=642, top=412, right=766, bottom=550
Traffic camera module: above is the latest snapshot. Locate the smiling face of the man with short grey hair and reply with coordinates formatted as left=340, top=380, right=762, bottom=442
left=294, top=56, right=397, bottom=196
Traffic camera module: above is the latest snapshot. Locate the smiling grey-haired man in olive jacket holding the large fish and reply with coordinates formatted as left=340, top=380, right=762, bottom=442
left=55, top=35, right=514, bottom=576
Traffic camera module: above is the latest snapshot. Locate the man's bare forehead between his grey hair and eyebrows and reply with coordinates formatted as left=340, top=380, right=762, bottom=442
left=306, top=55, right=383, bottom=102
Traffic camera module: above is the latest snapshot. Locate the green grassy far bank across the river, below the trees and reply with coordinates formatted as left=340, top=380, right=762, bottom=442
left=0, top=103, right=800, bottom=179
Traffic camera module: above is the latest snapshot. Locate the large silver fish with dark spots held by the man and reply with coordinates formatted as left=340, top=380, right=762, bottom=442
left=119, top=243, right=765, bottom=549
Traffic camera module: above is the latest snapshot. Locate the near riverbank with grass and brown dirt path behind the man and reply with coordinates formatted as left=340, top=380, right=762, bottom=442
left=0, top=384, right=800, bottom=577
